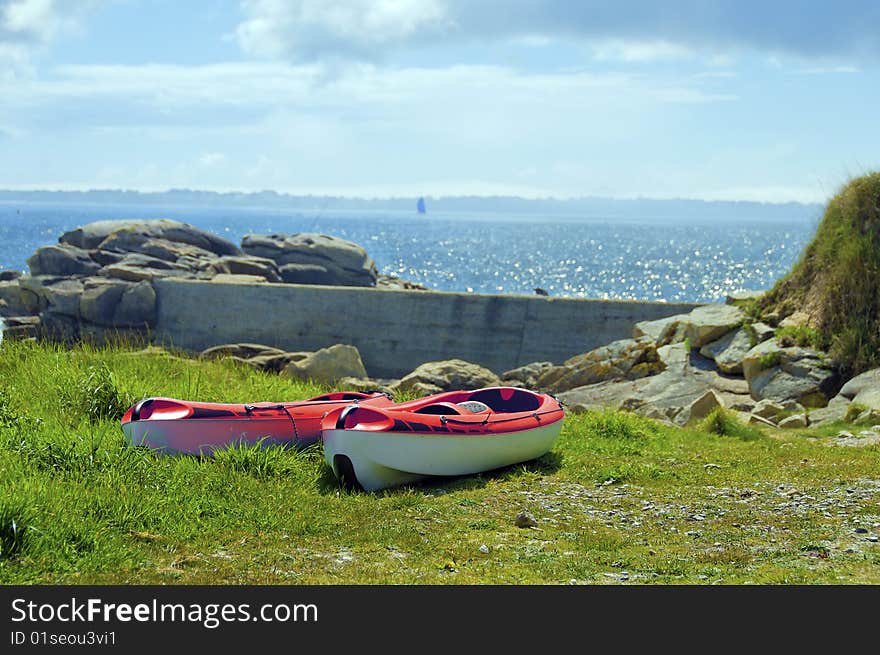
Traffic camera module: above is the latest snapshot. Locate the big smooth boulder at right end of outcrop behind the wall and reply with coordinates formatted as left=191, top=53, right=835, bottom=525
left=241, top=233, right=378, bottom=287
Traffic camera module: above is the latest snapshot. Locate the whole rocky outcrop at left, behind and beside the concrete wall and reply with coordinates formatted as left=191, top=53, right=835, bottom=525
left=0, top=219, right=412, bottom=348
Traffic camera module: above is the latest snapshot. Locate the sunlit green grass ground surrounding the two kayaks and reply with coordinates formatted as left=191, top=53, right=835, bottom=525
left=0, top=341, right=880, bottom=584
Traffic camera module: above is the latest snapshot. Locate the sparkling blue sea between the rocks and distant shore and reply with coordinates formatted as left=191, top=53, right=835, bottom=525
left=0, top=203, right=816, bottom=302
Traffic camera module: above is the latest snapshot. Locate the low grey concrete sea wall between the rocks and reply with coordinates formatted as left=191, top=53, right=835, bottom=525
left=154, top=279, right=696, bottom=377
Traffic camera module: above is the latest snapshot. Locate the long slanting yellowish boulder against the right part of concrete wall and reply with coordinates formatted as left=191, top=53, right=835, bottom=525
left=535, top=337, right=665, bottom=393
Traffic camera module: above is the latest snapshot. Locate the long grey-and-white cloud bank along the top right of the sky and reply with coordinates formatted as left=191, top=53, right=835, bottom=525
left=237, top=0, right=880, bottom=65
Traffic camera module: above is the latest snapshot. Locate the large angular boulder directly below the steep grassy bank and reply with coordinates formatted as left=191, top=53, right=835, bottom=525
left=742, top=339, right=840, bottom=407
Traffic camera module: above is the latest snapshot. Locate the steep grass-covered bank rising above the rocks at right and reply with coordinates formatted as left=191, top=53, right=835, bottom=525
left=761, top=173, right=880, bottom=374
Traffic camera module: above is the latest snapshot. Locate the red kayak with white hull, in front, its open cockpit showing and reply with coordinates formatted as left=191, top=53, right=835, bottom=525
left=321, top=387, right=565, bottom=491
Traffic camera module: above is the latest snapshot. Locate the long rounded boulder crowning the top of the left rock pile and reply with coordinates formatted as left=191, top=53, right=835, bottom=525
left=59, top=218, right=241, bottom=256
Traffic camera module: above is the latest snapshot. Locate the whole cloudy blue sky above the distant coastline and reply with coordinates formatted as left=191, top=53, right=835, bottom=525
left=0, top=0, right=880, bottom=202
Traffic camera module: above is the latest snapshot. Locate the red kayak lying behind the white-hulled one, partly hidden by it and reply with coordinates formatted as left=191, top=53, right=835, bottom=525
left=122, top=392, right=392, bottom=455
